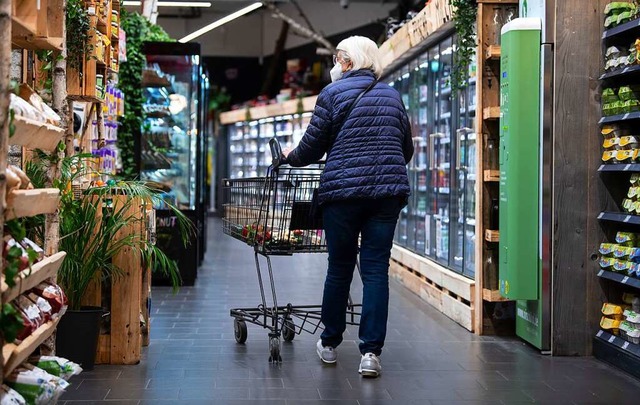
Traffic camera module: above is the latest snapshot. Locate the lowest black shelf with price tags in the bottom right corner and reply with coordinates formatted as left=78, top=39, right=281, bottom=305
left=593, top=330, right=640, bottom=378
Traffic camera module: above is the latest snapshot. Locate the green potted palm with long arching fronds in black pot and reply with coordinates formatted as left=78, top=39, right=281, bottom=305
left=31, top=152, right=193, bottom=310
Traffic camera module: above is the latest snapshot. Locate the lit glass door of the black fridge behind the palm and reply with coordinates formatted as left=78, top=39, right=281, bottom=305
left=140, top=44, right=200, bottom=210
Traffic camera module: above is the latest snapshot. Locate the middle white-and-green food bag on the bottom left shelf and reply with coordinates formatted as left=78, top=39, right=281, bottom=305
left=5, top=364, right=69, bottom=405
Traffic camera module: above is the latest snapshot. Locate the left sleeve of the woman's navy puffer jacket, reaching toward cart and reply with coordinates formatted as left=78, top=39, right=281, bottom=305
left=287, top=90, right=333, bottom=167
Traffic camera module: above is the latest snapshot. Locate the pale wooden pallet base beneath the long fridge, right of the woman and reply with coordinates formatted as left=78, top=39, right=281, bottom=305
left=389, top=246, right=475, bottom=331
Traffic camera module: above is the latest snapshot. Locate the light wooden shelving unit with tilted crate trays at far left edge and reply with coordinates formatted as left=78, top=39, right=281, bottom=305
left=0, top=0, right=66, bottom=378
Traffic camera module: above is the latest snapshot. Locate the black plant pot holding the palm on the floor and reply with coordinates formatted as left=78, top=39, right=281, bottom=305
left=56, top=307, right=104, bottom=371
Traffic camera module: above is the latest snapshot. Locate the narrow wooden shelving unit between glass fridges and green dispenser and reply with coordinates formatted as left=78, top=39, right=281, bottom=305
left=474, top=0, right=518, bottom=334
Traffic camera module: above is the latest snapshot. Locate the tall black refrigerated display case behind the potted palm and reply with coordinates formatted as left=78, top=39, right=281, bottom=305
left=141, top=42, right=204, bottom=285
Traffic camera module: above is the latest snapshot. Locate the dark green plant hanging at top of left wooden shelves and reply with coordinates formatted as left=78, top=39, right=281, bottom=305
left=65, top=0, right=93, bottom=69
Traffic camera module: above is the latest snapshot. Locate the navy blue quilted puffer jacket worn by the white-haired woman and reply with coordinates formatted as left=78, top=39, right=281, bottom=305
left=288, top=69, right=413, bottom=203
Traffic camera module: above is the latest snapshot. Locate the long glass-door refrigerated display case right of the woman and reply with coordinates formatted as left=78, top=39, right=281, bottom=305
left=383, top=36, right=477, bottom=278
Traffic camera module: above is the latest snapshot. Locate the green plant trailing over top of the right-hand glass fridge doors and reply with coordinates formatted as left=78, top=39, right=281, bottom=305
left=449, top=0, right=478, bottom=89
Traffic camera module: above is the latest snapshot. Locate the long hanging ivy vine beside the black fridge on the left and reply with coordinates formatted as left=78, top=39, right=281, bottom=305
left=118, top=10, right=173, bottom=180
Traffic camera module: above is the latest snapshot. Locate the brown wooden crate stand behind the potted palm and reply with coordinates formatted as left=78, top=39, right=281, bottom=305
left=83, top=196, right=151, bottom=364
